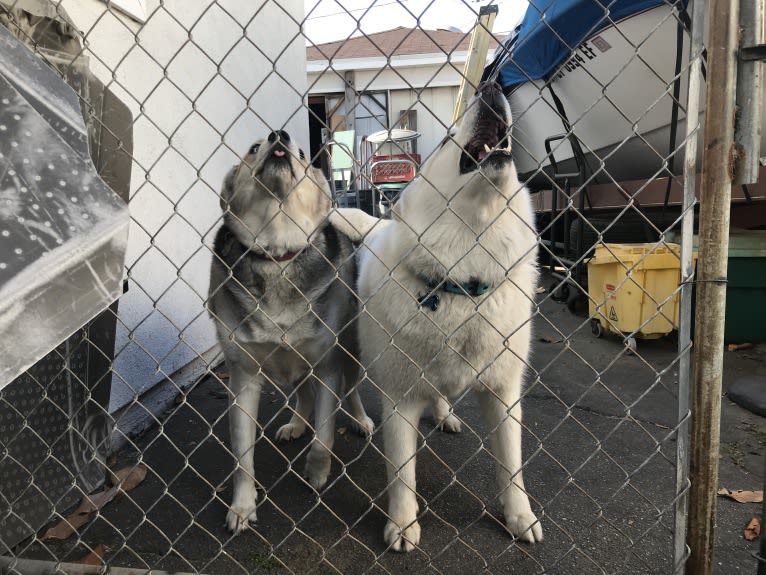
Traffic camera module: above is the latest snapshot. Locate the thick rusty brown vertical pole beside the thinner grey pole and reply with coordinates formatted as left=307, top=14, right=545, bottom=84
left=686, top=0, right=739, bottom=575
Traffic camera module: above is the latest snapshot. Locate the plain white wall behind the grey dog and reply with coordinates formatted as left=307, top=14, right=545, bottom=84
left=61, top=0, right=308, bottom=411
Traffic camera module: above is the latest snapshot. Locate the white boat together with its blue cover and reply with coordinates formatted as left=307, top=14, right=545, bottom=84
left=484, top=0, right=712, bottom=194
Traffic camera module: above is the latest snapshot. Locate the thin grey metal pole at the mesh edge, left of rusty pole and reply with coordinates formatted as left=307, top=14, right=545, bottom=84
left=673, top=2, right=705, bottom=575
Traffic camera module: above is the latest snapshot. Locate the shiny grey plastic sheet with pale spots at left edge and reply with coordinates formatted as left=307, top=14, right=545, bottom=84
left=0, top=25, right=129, bottom=387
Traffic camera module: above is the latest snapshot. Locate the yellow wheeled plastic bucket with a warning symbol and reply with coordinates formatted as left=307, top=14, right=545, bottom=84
left=588, top=244, right=696, bottom=348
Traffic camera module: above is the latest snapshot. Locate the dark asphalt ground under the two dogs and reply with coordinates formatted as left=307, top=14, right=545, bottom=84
left=18, top=276, right=766, bottom=575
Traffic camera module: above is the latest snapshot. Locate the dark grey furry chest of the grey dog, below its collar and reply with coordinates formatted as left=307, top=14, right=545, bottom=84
left=210, top=224, right=356, bottom=361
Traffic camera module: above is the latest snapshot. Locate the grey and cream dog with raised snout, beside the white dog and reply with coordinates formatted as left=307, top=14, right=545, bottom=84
left=208, top=130, right=373, bottom=533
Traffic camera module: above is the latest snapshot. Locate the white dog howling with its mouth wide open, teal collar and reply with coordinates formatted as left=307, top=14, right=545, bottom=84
left=336, top=83, right=543, bottom=551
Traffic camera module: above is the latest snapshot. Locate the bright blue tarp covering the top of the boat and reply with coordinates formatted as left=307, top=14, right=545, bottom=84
left=491, top=0, right=675, bottom=90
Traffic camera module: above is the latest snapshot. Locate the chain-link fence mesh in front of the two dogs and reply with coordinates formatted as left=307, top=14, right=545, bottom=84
left=0, top=0, right=763, bottom=574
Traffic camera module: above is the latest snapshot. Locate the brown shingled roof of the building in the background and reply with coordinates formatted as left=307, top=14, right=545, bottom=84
left=306, top=26, right=480, bottom=62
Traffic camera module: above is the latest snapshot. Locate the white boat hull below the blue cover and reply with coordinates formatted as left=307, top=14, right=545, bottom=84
left=509, top=5, right=728, bottom=188
